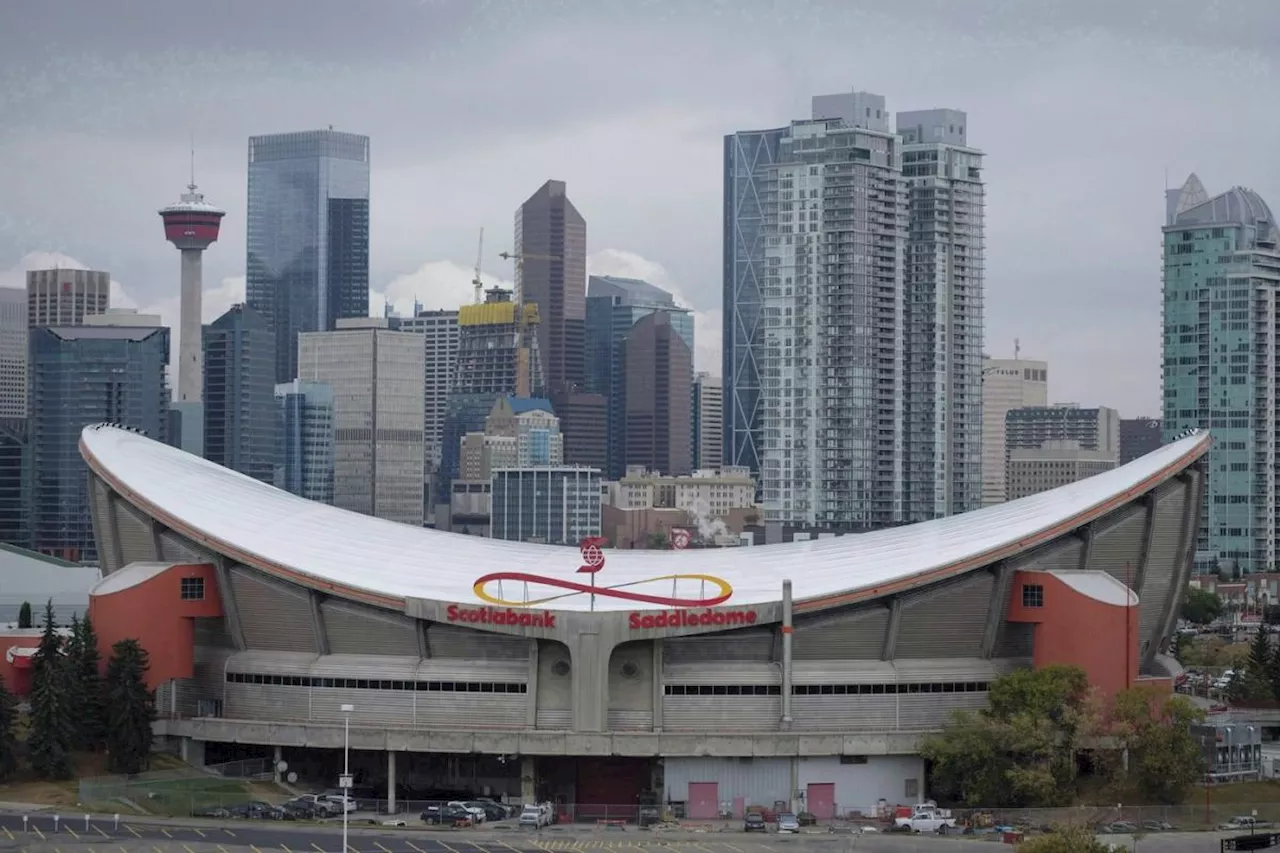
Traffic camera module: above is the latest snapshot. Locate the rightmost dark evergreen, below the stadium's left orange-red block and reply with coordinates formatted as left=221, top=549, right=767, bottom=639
left=106, top=639, right=156, bottom=774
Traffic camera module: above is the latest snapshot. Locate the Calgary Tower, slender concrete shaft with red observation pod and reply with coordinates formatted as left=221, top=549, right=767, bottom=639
left=160, top=162, right=227, bottom=455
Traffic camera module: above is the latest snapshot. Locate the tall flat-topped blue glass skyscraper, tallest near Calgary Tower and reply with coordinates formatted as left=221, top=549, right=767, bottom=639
left=246, top=131, right=369, bottom=382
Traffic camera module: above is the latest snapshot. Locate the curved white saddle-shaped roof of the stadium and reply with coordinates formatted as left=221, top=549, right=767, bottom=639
left=81, top=425, right=1210, bottom=611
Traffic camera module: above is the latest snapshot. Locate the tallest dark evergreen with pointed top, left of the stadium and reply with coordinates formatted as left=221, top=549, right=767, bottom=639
left=27, top=601, right=77, bottom=780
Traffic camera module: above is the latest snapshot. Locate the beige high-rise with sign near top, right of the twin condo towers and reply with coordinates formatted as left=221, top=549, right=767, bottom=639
left=982, top=357, right=1048, bottom=506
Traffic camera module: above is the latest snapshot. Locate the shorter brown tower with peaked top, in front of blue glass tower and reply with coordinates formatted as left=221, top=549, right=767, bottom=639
left=623, top=311, right=694, bottom=476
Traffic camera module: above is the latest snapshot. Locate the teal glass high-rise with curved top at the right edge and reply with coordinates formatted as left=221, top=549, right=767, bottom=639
left=1157, top=174, right=1280, bottom=571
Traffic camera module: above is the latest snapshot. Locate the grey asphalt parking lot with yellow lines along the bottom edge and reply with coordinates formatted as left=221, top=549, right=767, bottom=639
left=0, top=812, right=1249, bottom=853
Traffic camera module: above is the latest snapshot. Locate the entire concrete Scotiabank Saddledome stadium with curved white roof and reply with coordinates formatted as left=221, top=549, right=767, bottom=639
left=81, top=424, right=1210, bottom=818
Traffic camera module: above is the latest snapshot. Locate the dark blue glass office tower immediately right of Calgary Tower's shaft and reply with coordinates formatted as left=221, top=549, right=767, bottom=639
left=205, top=305, right=276, bottom=483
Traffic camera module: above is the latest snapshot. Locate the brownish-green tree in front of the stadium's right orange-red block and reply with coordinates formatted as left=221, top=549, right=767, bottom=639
left=1110, top=686, right=1204, bottom=804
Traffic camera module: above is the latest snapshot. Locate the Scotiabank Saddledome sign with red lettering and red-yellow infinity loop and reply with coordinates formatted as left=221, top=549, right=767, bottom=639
left=445, top=539, right=759, bottom=630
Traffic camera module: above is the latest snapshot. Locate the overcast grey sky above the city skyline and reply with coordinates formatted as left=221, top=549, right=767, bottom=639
left=0, top=0, right=1280, bottom=416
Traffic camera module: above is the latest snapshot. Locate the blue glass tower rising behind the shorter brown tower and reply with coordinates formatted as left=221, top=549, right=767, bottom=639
left=586, top=275, right=694, bottom=480
